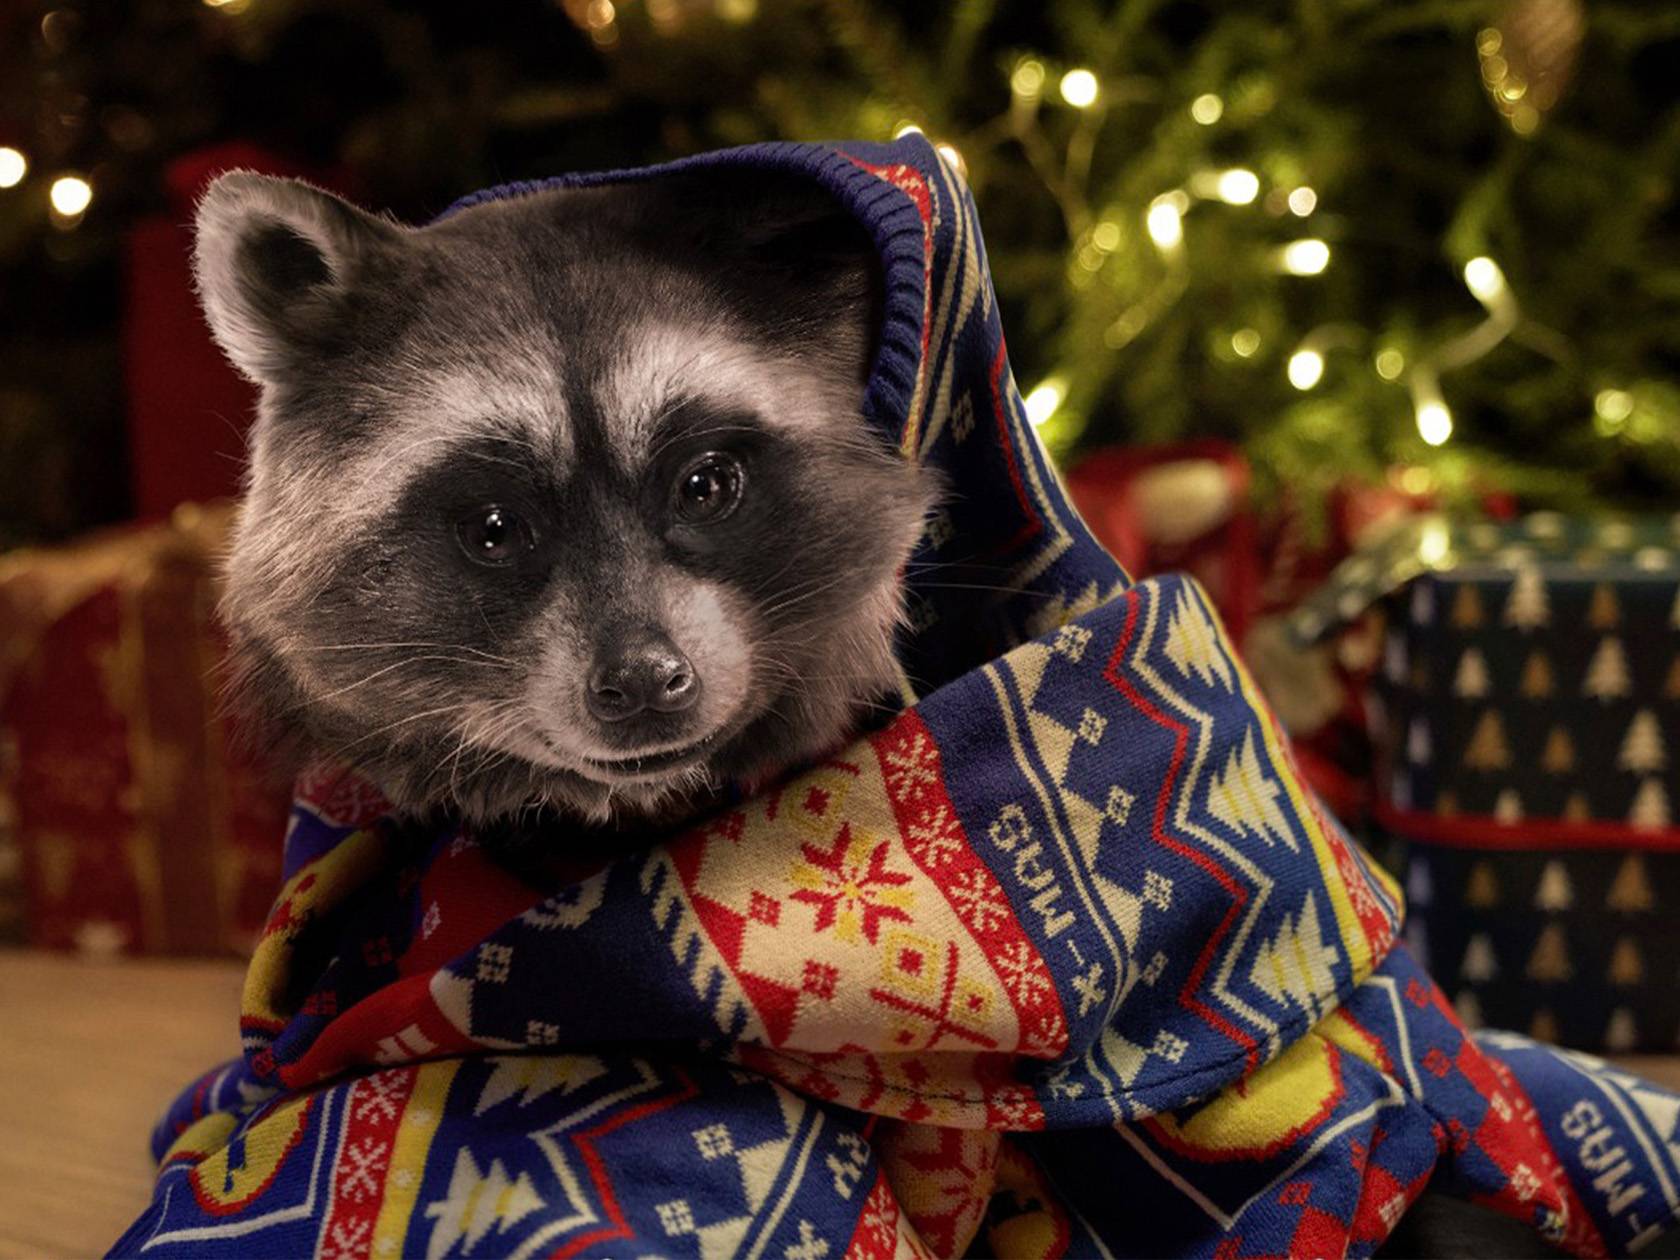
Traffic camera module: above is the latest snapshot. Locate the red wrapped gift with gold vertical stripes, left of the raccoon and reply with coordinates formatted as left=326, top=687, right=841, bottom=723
left=0, top=506, right=287, bottom=954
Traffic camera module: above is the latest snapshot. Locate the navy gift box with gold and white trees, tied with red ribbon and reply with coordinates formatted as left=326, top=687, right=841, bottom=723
left=1294, top=514, right=1680, bottom=1050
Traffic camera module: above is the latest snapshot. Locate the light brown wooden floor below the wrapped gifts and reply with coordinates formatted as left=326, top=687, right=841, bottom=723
left=0, top=951, right=1680, bottom=1260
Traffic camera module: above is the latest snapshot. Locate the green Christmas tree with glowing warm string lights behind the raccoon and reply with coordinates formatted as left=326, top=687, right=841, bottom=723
left=0, top=0, right=1680, bottom=551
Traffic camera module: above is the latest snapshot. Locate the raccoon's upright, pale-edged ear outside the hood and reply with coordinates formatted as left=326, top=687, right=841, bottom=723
left=193, top=171, right=402, bottom=383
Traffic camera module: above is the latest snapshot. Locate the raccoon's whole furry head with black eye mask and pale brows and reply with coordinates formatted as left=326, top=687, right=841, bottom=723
left=197, top=175, right=934, bottom=820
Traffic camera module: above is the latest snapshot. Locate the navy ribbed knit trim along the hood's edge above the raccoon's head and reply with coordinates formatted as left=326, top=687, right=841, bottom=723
left=438, top=133, right=939, bottom=460
